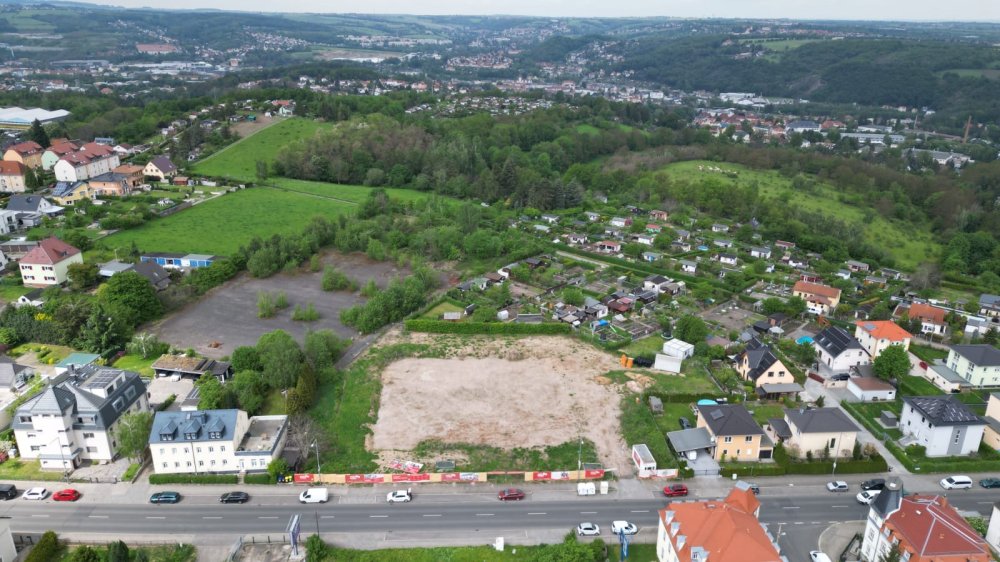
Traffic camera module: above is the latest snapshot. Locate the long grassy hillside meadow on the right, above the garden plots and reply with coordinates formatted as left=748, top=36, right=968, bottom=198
left=663, top=161, right=941, bottom=271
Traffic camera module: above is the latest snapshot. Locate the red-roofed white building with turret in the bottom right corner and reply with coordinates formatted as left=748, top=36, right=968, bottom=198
left=861, top=484, right=993, bottom=562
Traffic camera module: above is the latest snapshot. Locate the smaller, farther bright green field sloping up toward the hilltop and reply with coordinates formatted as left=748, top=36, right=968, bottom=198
left=192, top=117, right=332, bottom=181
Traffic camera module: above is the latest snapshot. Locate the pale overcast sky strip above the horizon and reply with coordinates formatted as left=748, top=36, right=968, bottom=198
left=91, top=0, right=1000, bottom=21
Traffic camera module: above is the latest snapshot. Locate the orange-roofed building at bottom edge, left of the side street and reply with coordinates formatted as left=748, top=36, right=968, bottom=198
left=656, top=482, right=786, bottom=562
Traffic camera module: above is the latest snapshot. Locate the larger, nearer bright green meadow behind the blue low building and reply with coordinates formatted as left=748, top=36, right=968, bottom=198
left=104, top=187, right=354, bottom=256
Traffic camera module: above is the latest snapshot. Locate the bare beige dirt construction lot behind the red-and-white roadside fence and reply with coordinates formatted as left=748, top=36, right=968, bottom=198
left=372, top=334, right=628, bottom=469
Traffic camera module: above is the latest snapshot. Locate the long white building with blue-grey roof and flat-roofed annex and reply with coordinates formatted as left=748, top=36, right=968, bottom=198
left=149, top=410, right=288, bottom=474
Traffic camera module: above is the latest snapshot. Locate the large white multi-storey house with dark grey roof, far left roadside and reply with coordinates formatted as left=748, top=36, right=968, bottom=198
left=11, top=365, right=149, bottom=472
